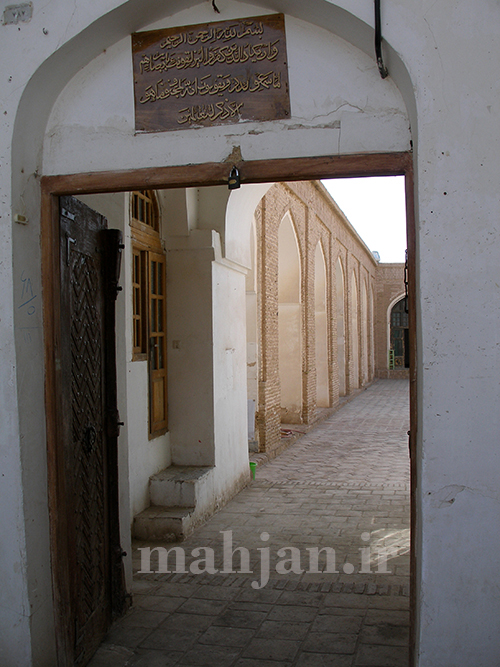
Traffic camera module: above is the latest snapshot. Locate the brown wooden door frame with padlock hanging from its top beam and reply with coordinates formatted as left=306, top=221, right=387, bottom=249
left=41, top=152, right=417, bottom=664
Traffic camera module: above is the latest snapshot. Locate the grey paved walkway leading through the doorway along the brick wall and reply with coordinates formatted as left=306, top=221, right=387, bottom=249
left=91, top=380, right=409, bottom=667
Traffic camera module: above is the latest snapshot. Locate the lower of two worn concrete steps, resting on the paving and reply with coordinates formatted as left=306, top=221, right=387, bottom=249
left=132, top=507, right=195, bottom=542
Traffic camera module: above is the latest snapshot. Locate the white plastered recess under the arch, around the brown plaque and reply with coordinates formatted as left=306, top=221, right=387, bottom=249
left=43, top=2, right=409, bottom=179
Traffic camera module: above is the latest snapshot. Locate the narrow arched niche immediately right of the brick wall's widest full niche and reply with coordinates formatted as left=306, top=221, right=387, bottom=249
left=314, top=241, right=330, bottom=408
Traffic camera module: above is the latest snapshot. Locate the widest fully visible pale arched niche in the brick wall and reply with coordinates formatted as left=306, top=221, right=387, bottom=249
left=278, top=213, right=302, bottom=423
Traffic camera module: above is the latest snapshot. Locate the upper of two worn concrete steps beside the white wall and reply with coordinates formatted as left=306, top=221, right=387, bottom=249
left=149, top=466, right=213, bottom=507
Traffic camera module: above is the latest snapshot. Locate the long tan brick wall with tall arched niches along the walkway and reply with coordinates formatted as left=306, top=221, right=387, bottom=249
left=255, top=181, right=404, bottom=451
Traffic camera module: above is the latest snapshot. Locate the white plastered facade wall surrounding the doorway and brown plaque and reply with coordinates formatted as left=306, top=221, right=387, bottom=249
left=0, top=0, right=500, bottom=667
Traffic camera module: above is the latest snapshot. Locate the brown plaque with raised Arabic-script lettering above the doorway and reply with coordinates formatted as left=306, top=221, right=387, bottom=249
left=132, top=14, right=290, bottom=132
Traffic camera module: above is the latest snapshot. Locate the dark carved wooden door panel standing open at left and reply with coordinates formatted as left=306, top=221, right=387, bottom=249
left=58, top=197, right=125, bottom=666
